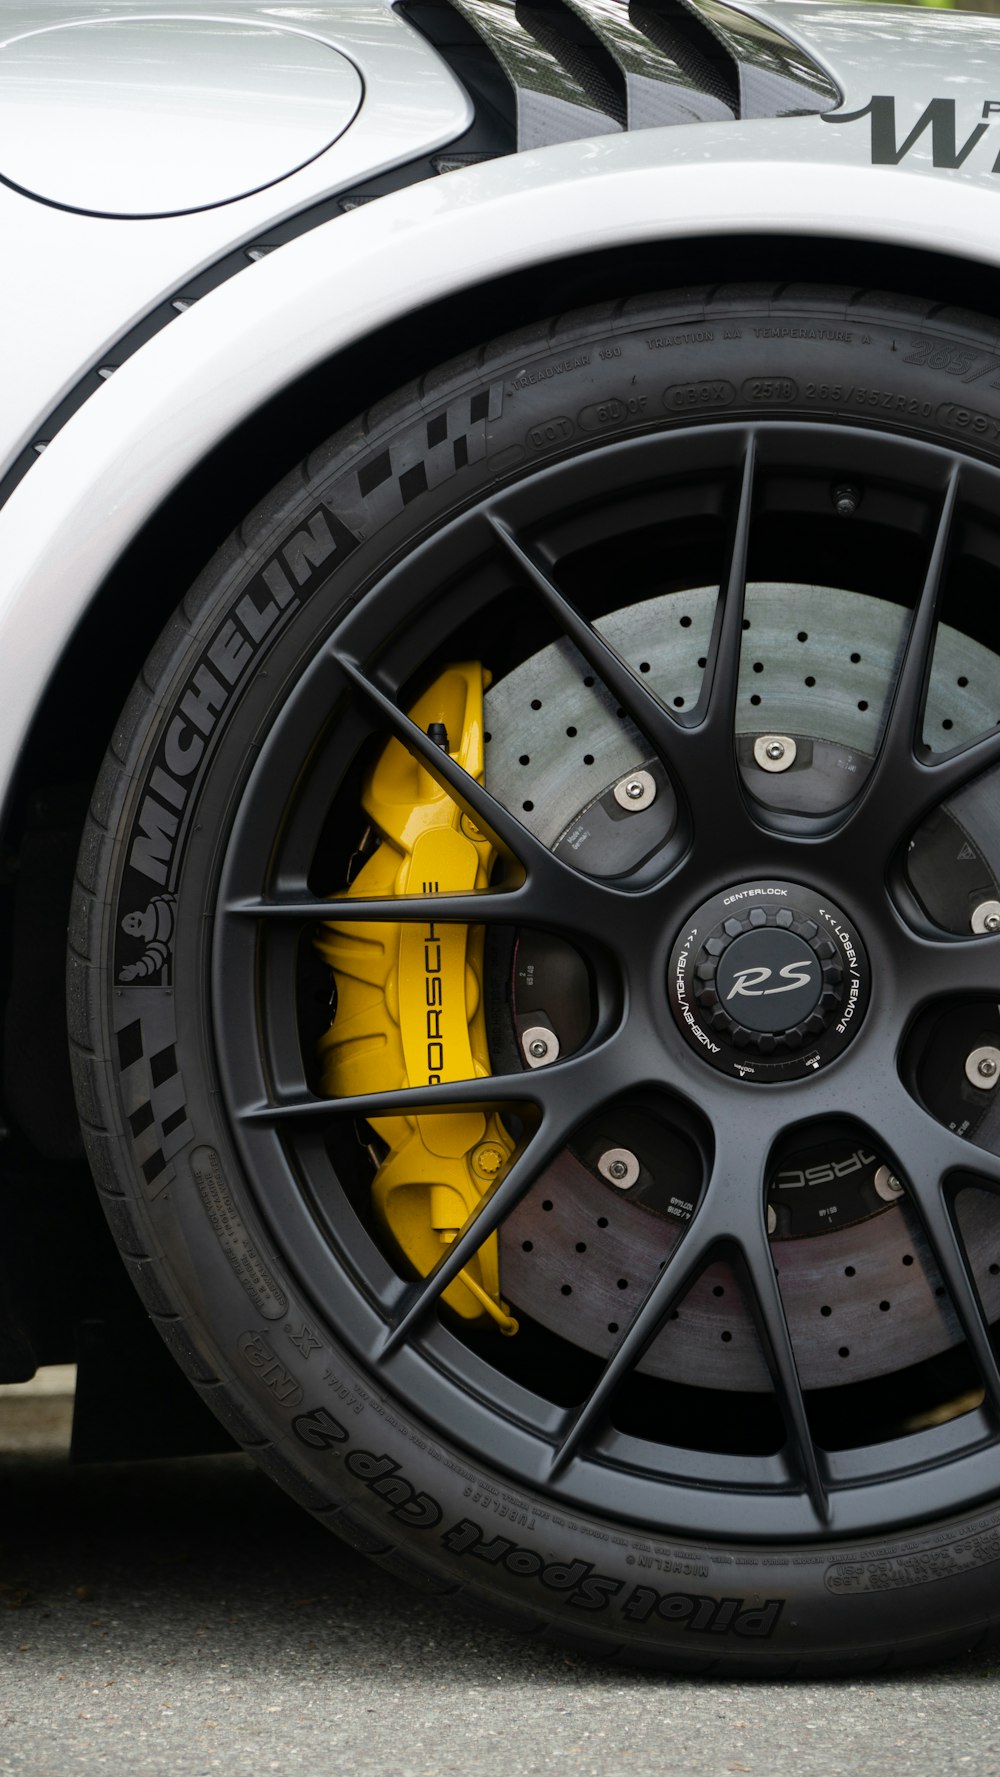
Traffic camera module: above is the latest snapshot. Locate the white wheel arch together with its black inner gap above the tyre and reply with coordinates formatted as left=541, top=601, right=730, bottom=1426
left=0, top=135, right=1000, bottom=819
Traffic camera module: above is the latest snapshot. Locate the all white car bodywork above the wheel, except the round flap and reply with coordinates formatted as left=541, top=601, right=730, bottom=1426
left=0, top=0, right=1000, bottom=817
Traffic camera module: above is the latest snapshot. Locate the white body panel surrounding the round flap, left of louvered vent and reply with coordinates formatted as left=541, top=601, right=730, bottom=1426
left=0, top=0, right=472, bottom=474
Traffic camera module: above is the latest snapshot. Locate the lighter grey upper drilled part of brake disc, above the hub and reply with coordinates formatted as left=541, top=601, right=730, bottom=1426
left=485, top=583, right=1000, bottom=844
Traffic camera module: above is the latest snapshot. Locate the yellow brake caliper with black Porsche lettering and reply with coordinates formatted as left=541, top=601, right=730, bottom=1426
left=318, top=663, right=517, bottom=1333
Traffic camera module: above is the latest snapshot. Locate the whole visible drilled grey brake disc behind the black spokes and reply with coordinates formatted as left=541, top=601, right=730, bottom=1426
left=485, top=585, right=1000, bottom=1390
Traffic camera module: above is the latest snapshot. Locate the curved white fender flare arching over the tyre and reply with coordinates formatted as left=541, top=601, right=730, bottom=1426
left=0, top=119, right=1000, bottom=807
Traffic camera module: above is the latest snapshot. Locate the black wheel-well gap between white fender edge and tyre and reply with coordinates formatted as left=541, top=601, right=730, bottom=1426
left=11, top=223, right=1000, bottom=860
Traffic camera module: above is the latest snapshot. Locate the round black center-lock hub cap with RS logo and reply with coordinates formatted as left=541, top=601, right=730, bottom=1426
left=668, top=881, right=870, bottom=1080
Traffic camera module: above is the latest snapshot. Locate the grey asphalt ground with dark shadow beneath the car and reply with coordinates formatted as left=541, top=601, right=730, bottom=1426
left=0, top=1377, right=1000, bottom=1777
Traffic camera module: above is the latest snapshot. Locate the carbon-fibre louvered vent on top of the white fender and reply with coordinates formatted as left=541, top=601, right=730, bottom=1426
left=405, top=0, right=840, bottom=149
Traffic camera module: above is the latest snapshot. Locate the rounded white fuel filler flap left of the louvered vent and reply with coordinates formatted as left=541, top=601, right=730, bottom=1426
left=0, top=12, right=364, bottom=220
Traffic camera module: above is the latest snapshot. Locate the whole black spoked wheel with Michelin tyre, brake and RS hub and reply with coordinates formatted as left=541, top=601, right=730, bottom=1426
left=69, top=290, right=1000, bottom=1672
